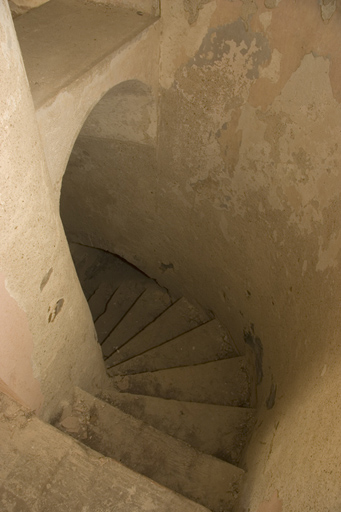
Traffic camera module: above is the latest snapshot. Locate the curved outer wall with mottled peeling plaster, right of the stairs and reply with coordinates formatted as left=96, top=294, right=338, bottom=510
left=59, top=0, right=341, bottom=512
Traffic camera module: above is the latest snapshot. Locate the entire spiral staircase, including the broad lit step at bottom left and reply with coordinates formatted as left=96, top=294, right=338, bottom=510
left=0, top=244, right=254, bottom=512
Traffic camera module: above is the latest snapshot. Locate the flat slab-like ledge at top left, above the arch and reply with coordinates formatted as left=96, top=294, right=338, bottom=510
left=14, top=0, right=158, bottom=109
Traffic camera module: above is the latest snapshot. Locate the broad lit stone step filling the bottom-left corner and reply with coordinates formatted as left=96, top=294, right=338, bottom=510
left=0, top=394, right=209, bottom=512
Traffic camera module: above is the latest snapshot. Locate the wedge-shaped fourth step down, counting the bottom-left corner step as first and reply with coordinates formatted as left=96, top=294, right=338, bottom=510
left=112, top=357, right=250, bottom=407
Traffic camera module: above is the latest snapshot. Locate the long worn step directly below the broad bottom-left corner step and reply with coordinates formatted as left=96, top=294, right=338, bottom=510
left=60, top=390, right=244, bottom=512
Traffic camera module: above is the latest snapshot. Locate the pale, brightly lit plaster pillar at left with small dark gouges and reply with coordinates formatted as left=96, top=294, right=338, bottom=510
left=0, top=0, right=106, bottom=419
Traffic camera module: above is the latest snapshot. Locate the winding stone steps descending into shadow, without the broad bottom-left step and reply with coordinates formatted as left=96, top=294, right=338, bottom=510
left=51, top=244, right=254, bottom=512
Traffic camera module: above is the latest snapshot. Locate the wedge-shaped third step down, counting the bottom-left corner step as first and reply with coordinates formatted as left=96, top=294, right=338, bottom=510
left=105, top=393, right=255, bottom=464
